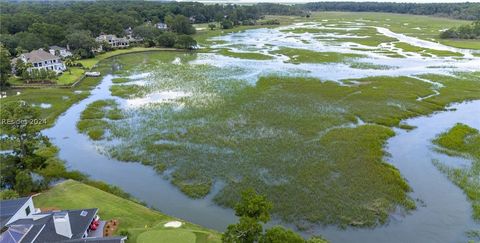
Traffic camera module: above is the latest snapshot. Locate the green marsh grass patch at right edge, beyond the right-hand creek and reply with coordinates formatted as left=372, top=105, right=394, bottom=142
left=433, top=124, right=480, bottom=221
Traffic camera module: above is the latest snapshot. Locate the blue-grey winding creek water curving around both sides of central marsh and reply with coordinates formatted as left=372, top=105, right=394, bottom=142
left=44, top=23, right=480, bottom=242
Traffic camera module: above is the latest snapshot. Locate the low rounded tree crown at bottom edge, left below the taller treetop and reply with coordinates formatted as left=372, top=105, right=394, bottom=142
left=222, top=217, right=263, bottom=243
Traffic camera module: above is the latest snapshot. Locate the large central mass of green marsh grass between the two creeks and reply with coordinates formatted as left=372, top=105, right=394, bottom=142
left=89, top=49, right=480, bottom=227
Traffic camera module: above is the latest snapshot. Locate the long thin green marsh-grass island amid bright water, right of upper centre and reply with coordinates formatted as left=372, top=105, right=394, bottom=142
left=273, top=48, right=364, bottom=63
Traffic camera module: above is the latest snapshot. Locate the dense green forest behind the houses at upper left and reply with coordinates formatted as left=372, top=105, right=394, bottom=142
left=0, top=1, right=302, bottom=57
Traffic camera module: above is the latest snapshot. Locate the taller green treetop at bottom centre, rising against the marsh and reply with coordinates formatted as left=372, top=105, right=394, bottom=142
left=235, top=188, right=273, bottom=223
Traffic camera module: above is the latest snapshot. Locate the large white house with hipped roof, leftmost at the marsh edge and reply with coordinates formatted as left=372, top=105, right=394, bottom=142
left=18, top=49, right=67, bottom=73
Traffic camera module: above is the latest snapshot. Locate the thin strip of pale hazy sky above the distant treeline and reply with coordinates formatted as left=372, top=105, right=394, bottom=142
left=178, top=0, right=480, bottom=3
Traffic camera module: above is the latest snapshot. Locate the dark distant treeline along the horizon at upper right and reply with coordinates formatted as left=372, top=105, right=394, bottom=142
left=300, top=2, right=480, bottom=20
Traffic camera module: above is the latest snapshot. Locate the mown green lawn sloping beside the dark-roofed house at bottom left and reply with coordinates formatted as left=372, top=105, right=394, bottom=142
left=34, top=180, right=220, bottom=243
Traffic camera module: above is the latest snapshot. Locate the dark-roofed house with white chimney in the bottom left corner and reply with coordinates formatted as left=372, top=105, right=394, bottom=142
left=0, top=197, right=126, bottom=243
